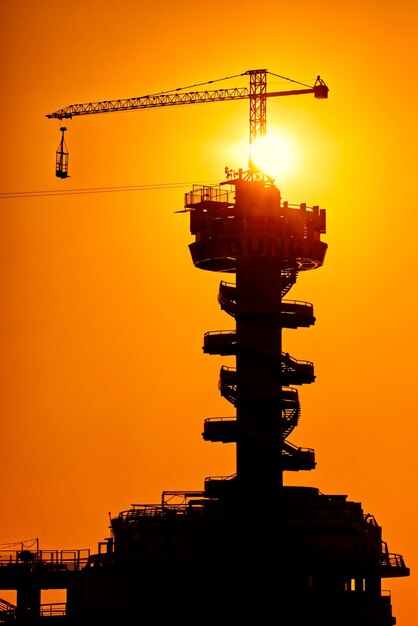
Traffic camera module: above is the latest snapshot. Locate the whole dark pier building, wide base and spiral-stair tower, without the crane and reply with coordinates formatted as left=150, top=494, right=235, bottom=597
left=0, top=70, right=409, bottom=626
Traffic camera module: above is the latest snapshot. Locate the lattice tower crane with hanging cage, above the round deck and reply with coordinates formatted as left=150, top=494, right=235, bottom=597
left=46, top=69, right=328, bottom=180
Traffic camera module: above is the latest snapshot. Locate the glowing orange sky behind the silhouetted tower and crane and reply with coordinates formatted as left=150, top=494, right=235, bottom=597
left=0, top=0, right=418, bottom=626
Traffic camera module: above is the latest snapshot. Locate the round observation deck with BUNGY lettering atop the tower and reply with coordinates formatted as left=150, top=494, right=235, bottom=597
left=185, top=179, right=327, bottom=272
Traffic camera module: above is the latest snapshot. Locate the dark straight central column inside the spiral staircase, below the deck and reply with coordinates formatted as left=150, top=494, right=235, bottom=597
left=236, top=256, right=282, bottom=499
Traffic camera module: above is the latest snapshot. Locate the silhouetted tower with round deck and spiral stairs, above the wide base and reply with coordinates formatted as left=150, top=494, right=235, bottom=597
left=194, top=172, right=327, bottom=494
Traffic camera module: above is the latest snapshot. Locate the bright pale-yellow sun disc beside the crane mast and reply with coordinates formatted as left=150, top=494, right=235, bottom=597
left=251, top=129, right=298, bottom=180
